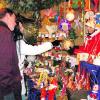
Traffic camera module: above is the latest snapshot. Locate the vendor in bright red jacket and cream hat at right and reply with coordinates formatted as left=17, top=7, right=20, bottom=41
left=75, top=20, right=100, bottom=61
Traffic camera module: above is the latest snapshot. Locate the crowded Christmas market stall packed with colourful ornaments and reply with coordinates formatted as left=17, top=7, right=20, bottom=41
left=0, top=0, right=100, bottom=100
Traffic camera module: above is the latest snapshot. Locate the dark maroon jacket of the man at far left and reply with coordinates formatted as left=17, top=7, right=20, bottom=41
left=0, top=22, right=21, bottom=95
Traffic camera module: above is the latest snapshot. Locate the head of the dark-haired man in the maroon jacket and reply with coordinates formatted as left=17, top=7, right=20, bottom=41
left=0, top=8, right=16, bottom=31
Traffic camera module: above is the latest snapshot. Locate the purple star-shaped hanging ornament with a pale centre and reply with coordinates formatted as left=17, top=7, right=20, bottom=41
left=58, top=19, right=71, bottom=33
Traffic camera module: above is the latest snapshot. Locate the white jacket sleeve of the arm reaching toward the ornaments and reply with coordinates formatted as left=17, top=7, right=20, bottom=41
left=17, top=40, right=53, bottom=55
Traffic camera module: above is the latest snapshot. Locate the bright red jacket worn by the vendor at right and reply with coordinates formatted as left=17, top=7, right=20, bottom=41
left=74, top=32, right=100, bottom=55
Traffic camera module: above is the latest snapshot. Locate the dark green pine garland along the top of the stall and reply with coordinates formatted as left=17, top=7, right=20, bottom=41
left=6, top=0, right=64, bottom=12
